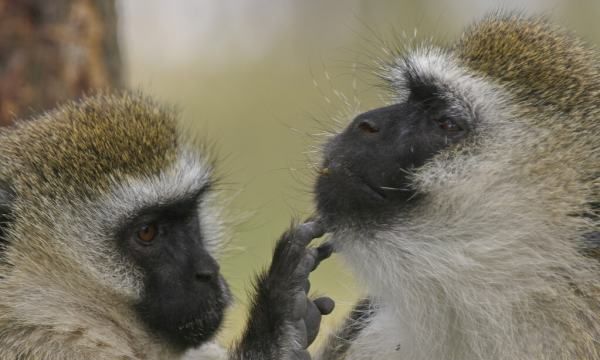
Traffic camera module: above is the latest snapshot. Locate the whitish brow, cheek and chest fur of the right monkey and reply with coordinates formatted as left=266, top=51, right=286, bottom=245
left=332, top=48, right=598, bottom=360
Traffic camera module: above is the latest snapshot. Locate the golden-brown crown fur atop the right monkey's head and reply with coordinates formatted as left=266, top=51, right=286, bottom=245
left=453, top=15, right=600, bottom=116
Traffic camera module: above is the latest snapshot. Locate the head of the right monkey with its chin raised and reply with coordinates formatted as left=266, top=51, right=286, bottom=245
left=315, top=15, right=600, bottom=270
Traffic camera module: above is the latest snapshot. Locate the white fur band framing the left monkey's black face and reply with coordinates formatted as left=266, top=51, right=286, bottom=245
left=81, top=150, right=223, bottom=297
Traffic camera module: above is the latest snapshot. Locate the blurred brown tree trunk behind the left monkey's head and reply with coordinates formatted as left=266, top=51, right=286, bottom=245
left=0, top=0, right=122, bottom=125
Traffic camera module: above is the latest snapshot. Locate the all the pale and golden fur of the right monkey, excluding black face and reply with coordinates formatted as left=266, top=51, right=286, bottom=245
left=316, top=14, right=600, bottom=360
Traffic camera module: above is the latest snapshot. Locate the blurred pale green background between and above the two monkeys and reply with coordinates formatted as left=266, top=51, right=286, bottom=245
left=119, top=0, right=600, bottom=348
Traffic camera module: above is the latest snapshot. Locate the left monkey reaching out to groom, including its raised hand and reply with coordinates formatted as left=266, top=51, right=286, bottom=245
left=0, top=93, right=333, bottom=360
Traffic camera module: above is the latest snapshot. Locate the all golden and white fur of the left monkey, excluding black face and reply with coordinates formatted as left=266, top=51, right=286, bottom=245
left=0, top=93, right=219, bottom=360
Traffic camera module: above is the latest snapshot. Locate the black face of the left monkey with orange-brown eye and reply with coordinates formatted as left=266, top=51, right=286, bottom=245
left=120, top=190, right=229, bottom=349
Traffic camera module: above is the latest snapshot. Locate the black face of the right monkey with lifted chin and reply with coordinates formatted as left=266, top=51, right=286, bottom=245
left=315, top=87, right=469, bottom=227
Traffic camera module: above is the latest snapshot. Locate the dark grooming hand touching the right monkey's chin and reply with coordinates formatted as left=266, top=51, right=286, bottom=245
left=234, top=222, right=335, bottom=360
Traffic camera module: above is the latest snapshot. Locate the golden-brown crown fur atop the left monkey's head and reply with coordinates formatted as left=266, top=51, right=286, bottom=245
left=0, top=93, right=178, bottom=200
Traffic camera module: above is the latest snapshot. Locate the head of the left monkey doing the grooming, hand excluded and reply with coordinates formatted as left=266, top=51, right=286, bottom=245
left=0, top=94, right=229, bottom=349
